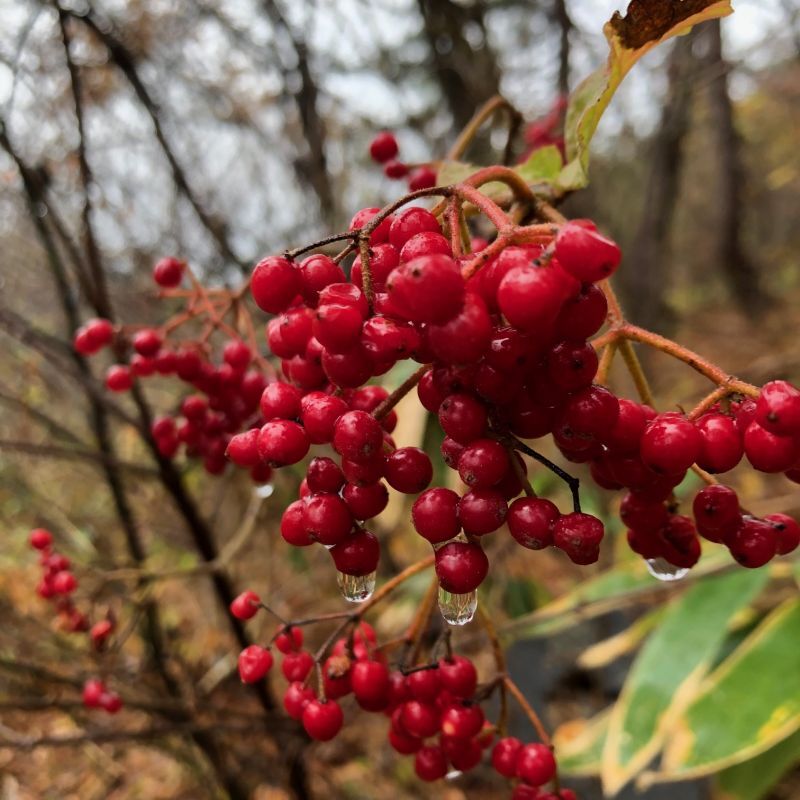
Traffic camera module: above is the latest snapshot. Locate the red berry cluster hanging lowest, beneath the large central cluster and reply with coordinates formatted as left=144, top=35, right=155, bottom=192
left=230, top=591, right=575, bottom=800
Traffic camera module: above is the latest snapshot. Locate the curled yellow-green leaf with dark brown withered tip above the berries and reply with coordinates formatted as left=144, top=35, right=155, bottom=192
left=558, top=0, right=733, bottom=190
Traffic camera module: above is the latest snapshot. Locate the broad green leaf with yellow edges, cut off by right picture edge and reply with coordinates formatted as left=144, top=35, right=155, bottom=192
left=657, top=599, right=800, bottom=780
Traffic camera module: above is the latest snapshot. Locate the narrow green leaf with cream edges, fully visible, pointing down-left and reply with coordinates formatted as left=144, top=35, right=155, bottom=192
left=602, top=570, right=768, bottom=795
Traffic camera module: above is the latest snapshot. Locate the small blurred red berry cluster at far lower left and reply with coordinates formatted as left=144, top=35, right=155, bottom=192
left=29, top=528, right=122, bottom=714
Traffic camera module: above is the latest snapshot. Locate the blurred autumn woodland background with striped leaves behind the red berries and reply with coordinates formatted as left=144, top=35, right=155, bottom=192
left=0, top=0, right=800, bottom=800
